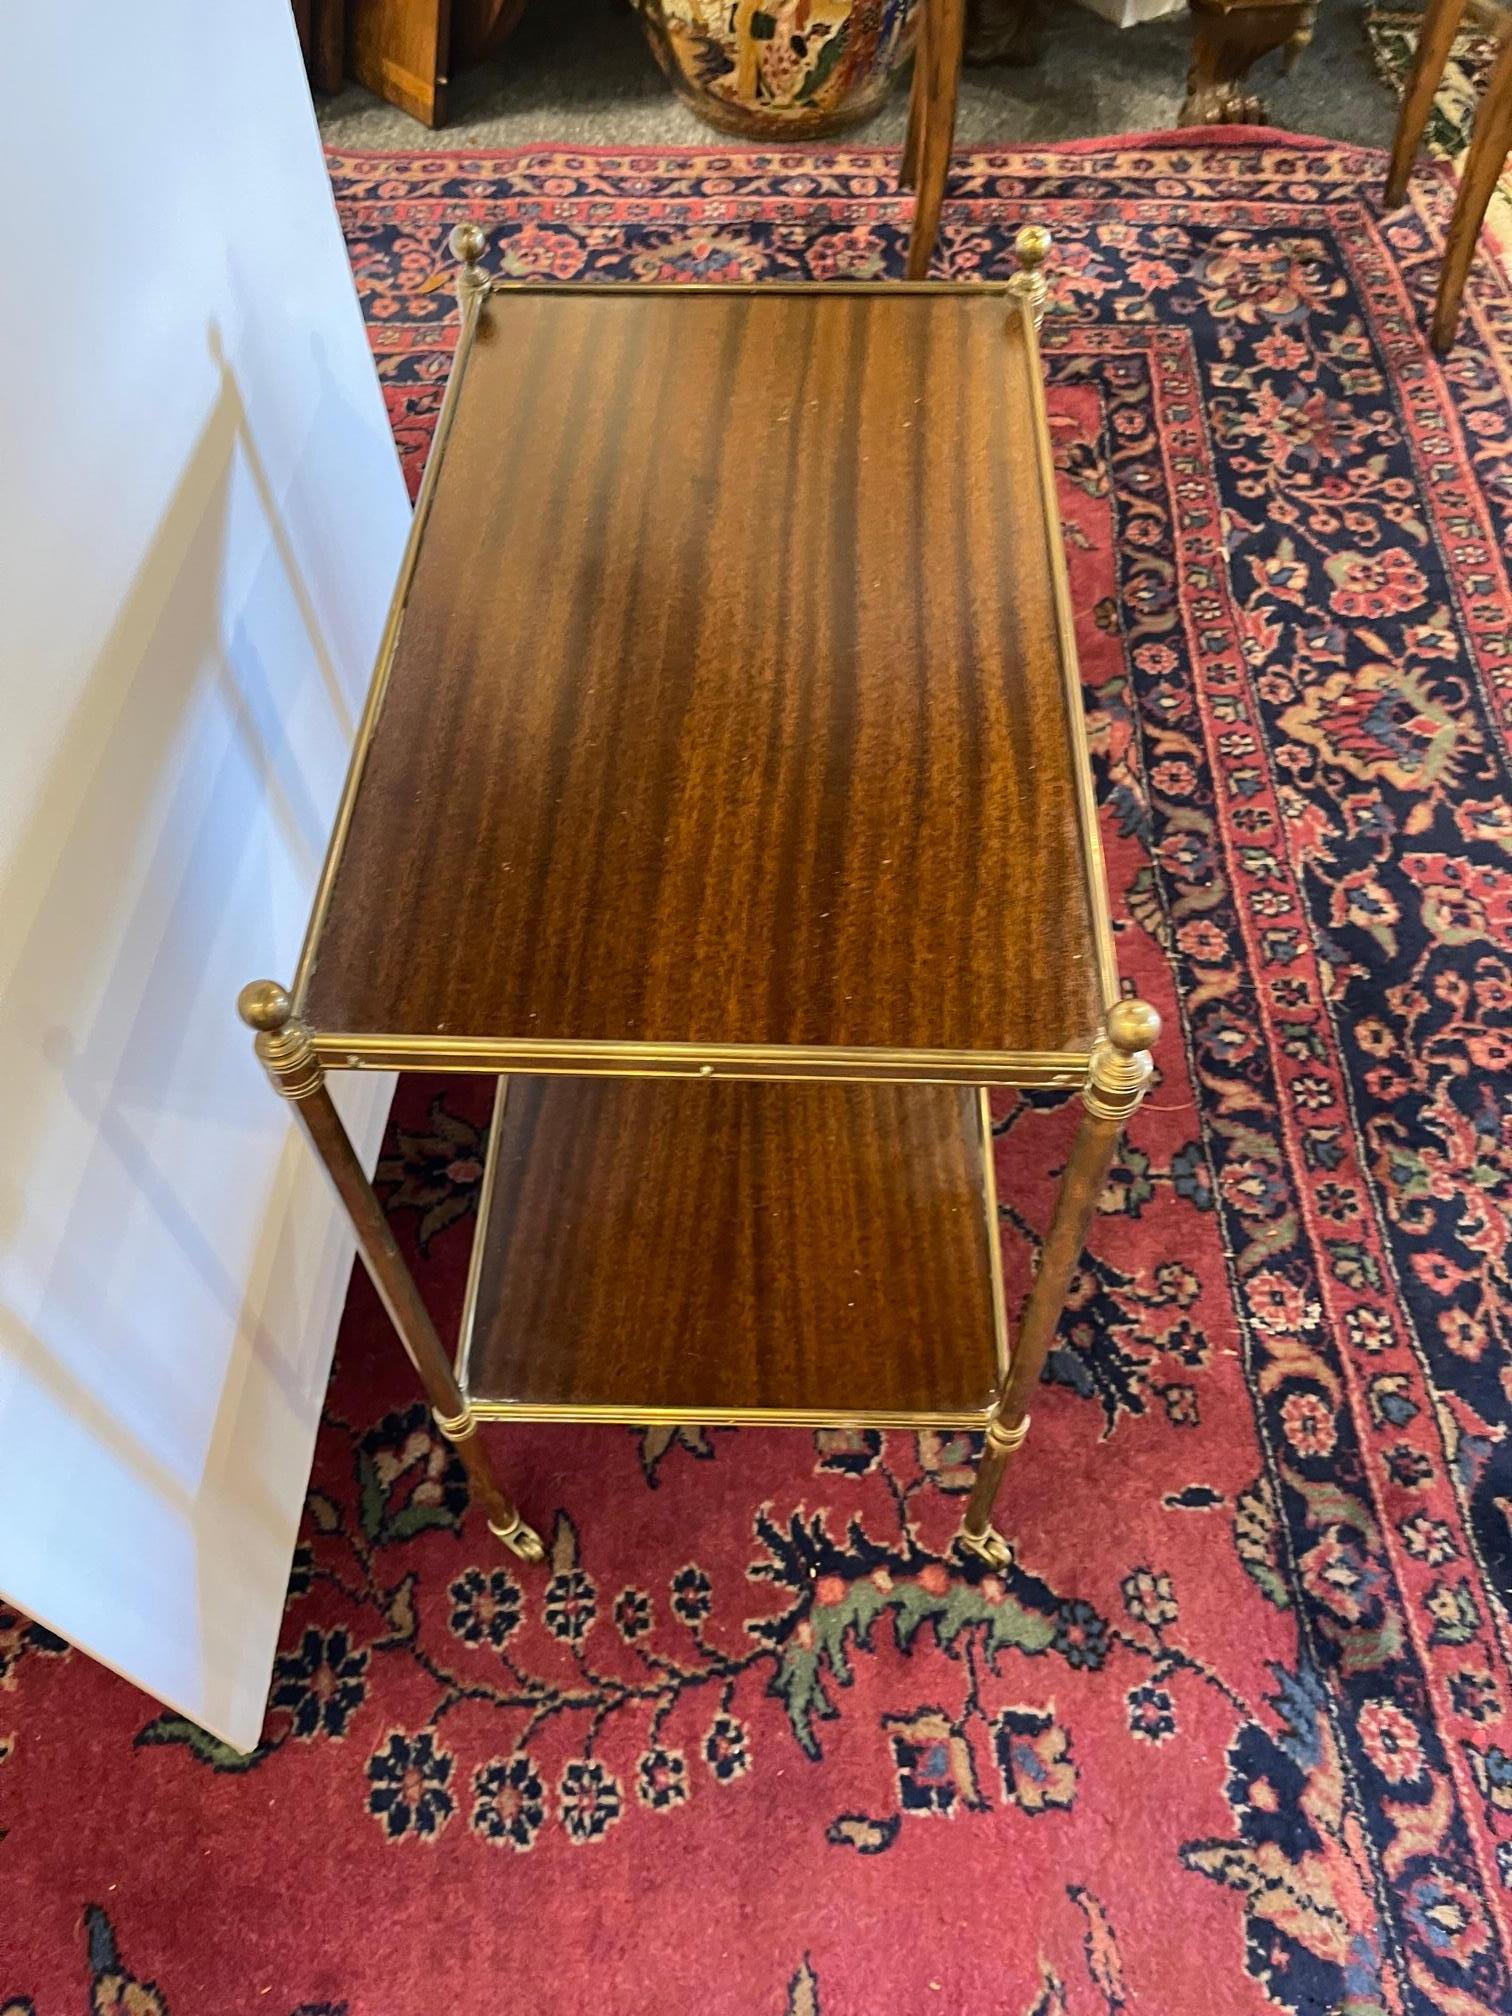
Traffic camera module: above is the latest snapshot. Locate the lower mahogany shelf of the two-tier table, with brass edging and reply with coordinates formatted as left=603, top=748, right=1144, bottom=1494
left=458, top=1079, right=1006, bottom=1427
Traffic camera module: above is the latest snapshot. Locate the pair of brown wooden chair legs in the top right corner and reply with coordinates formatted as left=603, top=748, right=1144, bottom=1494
left=1385, top=0, right=1512, bottom=353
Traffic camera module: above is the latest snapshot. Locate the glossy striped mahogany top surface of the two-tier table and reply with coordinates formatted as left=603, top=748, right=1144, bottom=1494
left=304, top=288, right=1101, bottom=1052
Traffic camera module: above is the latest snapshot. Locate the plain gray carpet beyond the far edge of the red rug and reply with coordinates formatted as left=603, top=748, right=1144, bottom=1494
left=319, top=0, right=1397, bottom=151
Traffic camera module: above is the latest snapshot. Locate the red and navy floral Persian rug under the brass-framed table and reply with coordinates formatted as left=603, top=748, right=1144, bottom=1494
left=0, top=131, right=1512, bottom=2016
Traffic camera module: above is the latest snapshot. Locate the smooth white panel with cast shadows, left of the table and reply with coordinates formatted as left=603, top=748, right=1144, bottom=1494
left=0, top=0, right=407, bottom=1748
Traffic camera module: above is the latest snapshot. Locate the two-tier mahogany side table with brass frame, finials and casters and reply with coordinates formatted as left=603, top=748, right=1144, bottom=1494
left=240, top=226, right=1159, bottom=1562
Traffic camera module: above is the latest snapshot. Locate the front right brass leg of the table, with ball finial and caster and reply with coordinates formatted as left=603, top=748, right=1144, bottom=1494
left=956, top=1000, right=1161, bottom=1568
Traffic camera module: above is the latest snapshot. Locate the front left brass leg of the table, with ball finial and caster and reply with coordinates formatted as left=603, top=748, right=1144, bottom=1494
left=236, top=980, right=546, bottom=1560
